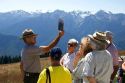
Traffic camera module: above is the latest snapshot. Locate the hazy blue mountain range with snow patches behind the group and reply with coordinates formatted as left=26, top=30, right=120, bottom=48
left=0, top=10, right=125, bottom=54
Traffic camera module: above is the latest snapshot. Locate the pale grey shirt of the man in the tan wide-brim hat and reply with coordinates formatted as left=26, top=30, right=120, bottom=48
left=82, top=50, right=113, bottom=83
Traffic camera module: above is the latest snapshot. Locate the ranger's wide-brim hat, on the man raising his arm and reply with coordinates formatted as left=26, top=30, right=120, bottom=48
left=20, top=29, right=38, bottom=39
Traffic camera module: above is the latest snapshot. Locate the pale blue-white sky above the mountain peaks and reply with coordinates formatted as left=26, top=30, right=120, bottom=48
left=0, top=0, right=125, bottom=13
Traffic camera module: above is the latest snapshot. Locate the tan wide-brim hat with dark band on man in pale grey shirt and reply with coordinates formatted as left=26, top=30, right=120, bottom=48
left=88, top=32, right=110, bottom=44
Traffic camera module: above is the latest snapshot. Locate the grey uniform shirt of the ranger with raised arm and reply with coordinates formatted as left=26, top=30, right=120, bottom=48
left=21, top=45, right=43, bottom=73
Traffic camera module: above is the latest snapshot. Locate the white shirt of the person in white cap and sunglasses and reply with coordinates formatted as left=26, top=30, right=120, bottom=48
left=62, top=52, right=76, bottom=72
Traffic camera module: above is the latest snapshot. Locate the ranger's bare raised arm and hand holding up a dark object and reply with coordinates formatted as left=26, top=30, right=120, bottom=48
left=40, top=31, right=64, bottom=53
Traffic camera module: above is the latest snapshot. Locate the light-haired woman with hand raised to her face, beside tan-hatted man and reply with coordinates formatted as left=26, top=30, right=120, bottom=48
left=73, top=37, right=92, bottom=83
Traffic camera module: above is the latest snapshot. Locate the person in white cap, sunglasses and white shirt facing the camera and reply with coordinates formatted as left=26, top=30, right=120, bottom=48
left=60, top=39, right=78, bottom=72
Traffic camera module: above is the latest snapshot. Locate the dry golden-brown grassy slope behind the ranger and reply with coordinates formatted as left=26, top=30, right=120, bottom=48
left=0, top=58, right=50, bottom=83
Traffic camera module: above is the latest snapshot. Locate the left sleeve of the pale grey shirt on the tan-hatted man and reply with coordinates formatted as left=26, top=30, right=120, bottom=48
left=82, top=52, right=95, bottom=77
